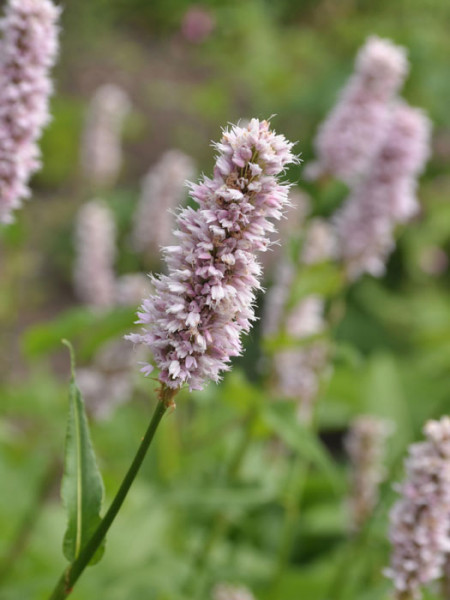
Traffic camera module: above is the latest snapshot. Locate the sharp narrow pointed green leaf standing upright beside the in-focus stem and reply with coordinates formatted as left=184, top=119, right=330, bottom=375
left=61, top=340, right=104, bottom=564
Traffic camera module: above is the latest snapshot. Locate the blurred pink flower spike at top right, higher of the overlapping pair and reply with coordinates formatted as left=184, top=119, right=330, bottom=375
left=305, top=36, right=408, bottom=183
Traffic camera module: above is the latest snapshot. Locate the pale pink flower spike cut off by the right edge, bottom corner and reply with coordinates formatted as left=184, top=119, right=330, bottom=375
left=386, top=417, right=450, bottom=600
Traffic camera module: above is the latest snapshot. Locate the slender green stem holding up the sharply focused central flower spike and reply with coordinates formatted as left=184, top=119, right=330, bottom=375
left=49, top=388, right=174, bottom=600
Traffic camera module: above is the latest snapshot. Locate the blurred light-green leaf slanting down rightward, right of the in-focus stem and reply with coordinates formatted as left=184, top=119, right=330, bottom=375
left=264, top=402, right=344, bottom=493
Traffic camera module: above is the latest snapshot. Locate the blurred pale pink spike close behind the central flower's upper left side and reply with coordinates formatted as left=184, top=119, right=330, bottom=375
left=133, top=150, right=195, bottom=259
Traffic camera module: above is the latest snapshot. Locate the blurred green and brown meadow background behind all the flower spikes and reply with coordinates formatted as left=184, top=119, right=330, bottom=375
left=0, top=0, right=450, bottom=600
